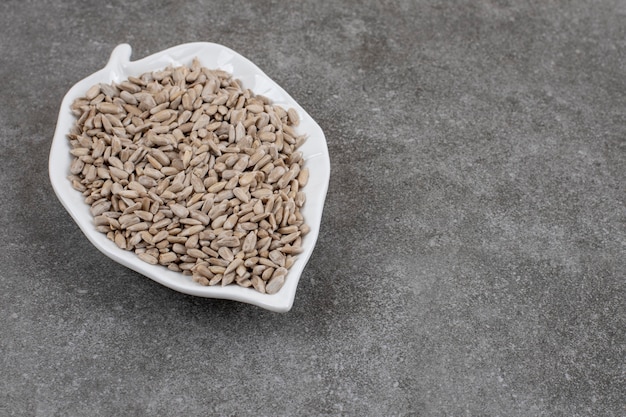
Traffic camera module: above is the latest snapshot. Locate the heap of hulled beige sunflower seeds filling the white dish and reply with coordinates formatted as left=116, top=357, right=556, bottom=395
left=68, top=60, right=310, bottom=294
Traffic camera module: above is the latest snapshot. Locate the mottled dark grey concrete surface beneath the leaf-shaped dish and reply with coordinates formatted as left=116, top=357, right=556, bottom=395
left=0, top=0, right=626, bottom=416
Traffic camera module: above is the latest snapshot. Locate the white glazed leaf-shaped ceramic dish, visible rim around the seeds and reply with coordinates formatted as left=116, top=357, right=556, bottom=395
left=49, top=42, right=330, bottom=312
